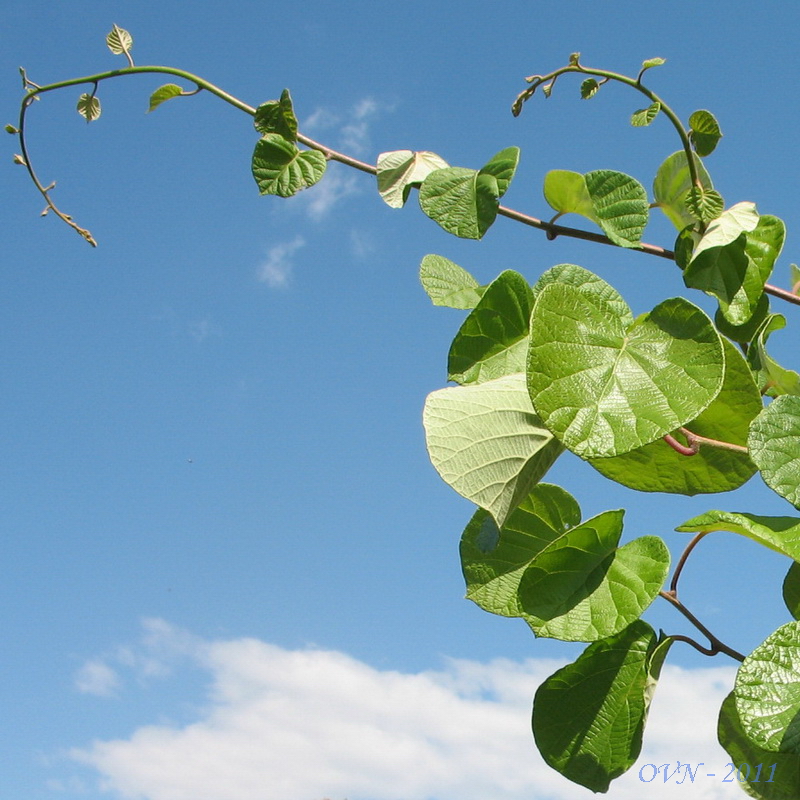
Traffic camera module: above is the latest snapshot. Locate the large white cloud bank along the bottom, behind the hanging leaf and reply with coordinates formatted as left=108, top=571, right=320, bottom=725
left=72, top=622, right=740, bottom=800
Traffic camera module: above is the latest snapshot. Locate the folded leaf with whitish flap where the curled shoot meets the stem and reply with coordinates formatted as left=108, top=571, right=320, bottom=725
left=683, top=203, right=786, bottom=325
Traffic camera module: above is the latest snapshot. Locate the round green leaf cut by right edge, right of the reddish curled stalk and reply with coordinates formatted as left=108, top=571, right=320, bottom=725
left=749, top=395, right=800, bottom=508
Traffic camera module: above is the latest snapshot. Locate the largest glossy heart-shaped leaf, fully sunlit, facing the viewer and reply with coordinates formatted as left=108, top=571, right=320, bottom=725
left=528, top=283, right=724, bottom=458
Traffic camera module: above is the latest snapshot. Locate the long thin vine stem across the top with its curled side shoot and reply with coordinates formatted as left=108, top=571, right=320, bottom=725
left=18, top=65, right=800, bottom=305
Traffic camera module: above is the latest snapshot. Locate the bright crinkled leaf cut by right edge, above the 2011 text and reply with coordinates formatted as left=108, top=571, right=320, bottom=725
left=733, top=622, right=800, bottom=755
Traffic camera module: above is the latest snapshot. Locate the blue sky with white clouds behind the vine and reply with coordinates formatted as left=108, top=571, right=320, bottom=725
left=0, top=0, right=800, bottom=800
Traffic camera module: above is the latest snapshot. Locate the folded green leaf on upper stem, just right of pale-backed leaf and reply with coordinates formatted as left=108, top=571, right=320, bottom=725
left=419, top=147, right=519, bottom=239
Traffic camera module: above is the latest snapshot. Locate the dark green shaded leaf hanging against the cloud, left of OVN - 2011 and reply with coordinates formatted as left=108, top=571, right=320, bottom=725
left=533, top=620, right=670, bottom=792
